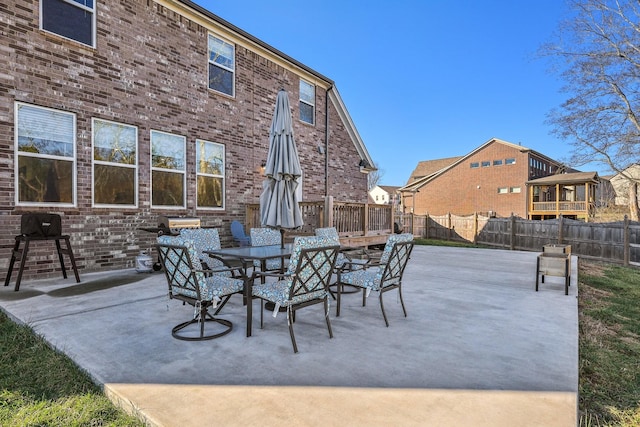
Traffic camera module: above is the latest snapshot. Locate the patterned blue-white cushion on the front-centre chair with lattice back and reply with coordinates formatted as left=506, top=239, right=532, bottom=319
left=253, top=237, right=337, bottom=307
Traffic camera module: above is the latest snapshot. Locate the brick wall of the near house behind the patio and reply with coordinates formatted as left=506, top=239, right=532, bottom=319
left=0, top=0, right=367, bottom=278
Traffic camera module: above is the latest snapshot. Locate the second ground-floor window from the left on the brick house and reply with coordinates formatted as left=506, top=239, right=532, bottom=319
left=91, top=118, right=138, bottom=207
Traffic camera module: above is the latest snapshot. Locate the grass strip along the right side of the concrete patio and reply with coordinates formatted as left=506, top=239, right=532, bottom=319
left=578, top=261, right=640, bottom=427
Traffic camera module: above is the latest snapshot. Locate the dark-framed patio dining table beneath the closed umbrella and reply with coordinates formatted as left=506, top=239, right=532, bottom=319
left=204, top=243, right=293, bottom=337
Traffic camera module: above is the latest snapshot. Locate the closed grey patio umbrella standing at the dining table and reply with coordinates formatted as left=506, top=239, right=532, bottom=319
left=260, top=89, right=304, bottom=247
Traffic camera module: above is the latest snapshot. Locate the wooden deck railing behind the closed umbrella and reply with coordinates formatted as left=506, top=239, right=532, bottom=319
left=246, top=197, right=394, bottom=241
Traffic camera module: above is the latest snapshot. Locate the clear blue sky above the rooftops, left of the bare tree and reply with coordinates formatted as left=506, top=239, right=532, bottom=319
left=196, top=0, right=606, bottom=185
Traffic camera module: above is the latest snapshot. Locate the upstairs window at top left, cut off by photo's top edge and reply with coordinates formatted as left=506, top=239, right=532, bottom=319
left=40, top=0, right=96, bottom=47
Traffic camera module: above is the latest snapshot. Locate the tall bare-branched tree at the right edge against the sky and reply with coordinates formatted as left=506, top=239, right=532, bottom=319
left=541, top=0, right=640, bottom=221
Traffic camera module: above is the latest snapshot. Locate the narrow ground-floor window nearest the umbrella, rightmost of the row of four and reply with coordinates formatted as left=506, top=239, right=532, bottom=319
left=196, top=139, right=225, bottom=209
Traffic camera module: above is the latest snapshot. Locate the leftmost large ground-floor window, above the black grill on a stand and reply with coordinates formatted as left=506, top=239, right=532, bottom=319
left=14, top=102, right=76, bottom=206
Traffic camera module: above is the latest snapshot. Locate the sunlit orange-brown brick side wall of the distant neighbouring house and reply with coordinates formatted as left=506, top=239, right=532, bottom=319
left=412, top=142, right=529, bottom=218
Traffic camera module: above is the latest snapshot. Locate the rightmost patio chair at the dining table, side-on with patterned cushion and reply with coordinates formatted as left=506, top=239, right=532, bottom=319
left=336, top=233, right=413, bottom=327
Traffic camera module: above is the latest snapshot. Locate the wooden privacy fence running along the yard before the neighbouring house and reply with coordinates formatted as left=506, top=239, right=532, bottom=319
left=396, top=214, right=640, bottom=266
